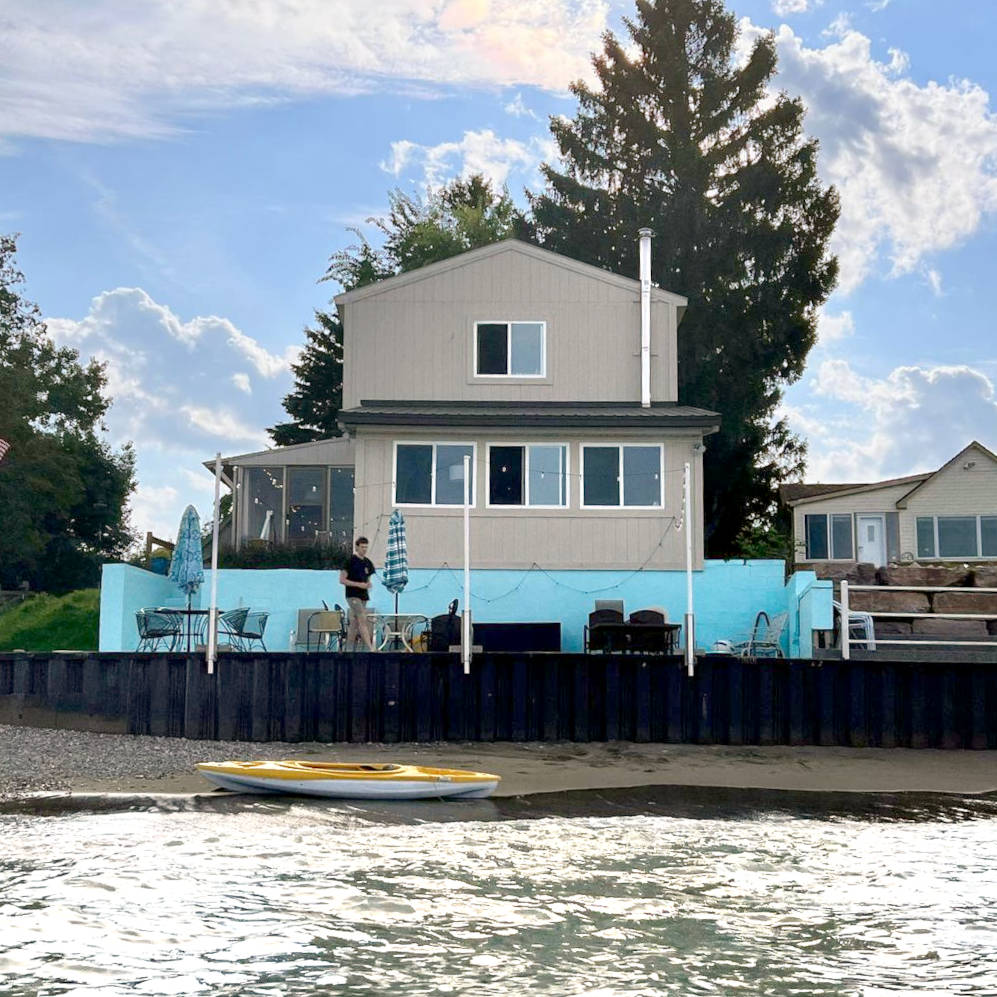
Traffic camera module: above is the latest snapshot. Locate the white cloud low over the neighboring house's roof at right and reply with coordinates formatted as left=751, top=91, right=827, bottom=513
left=783, top=359, right=997, bottom=481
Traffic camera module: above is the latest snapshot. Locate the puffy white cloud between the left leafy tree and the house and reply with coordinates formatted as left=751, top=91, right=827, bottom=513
left=46, top=288, right=299, bottom=537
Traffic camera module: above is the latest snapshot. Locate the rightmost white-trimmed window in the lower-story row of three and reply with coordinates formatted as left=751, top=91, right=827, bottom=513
left=581, top=443, right=665, bottom=509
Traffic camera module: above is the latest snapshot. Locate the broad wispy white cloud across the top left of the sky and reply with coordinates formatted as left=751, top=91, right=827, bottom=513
left=0, top=0, right=610, bottom=141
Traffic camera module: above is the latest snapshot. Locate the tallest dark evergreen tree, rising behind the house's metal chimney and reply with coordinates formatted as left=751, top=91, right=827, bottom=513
left=531, top=0, right=838, bottom=556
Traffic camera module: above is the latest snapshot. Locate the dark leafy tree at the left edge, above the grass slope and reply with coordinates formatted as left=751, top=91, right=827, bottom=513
left=0, top=236, right=135, bottom=593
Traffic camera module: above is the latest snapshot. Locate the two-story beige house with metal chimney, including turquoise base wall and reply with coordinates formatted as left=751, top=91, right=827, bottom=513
left=101, top=230, right=830, bottom=651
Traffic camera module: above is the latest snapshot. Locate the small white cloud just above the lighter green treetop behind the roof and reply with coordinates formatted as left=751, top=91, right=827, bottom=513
left=381, top=128, right=557, bottom=187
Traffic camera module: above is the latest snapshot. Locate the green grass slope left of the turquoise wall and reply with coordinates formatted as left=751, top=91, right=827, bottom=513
left=0, top=589, right=100, bottom=651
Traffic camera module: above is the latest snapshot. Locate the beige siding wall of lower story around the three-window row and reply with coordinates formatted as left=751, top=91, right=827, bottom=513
left=356, top=429, right=703, bottom=571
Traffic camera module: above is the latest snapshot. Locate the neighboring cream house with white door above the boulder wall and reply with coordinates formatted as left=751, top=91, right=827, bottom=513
left=779, top=440, right=997, bottom=567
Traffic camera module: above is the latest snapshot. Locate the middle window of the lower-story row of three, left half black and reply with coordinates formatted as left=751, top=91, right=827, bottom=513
left=486, top=443, right=568, bottom=509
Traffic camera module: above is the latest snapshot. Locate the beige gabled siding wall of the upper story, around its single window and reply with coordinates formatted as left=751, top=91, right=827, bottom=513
left=343, top=250, right=677, bottom=408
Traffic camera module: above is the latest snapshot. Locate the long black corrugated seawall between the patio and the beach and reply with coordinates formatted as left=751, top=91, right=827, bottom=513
left=0, top=652, right=997, bottom=748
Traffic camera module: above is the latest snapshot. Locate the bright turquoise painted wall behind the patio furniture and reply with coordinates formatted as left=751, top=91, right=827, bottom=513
left=100, top=560, right=831, bottom=655
